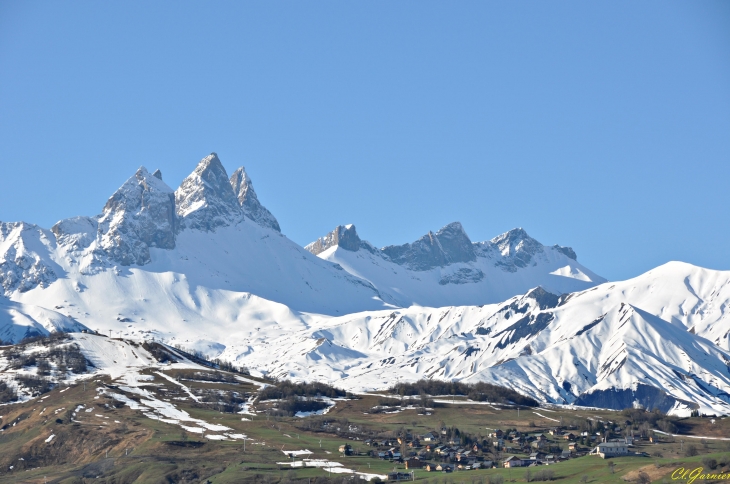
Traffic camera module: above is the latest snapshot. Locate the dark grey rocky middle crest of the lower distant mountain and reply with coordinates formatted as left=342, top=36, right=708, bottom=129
left=382, top=222, right=476, bottom=271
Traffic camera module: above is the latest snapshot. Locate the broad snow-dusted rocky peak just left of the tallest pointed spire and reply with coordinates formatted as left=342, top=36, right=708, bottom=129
left=97, top=167, right=177, bottom=265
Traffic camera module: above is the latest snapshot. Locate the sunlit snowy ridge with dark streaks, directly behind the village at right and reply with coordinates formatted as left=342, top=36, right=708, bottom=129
left=224, top=263, right=730, bottom=414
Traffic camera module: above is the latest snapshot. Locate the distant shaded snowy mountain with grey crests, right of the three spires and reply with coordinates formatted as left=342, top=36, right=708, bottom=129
left=305, top=222, right=605, bottom=307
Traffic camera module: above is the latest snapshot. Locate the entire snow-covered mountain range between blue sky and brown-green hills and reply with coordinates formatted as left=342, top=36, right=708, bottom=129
left=0, top=153, right=730, bottom=415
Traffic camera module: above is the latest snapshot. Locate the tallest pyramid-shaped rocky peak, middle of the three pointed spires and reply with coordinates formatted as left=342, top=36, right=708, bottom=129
left=175, top=153, right=244, bottom=231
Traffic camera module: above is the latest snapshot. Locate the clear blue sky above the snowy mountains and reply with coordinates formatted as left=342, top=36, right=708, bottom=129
left=0, top=1, right=730, bottom=279
